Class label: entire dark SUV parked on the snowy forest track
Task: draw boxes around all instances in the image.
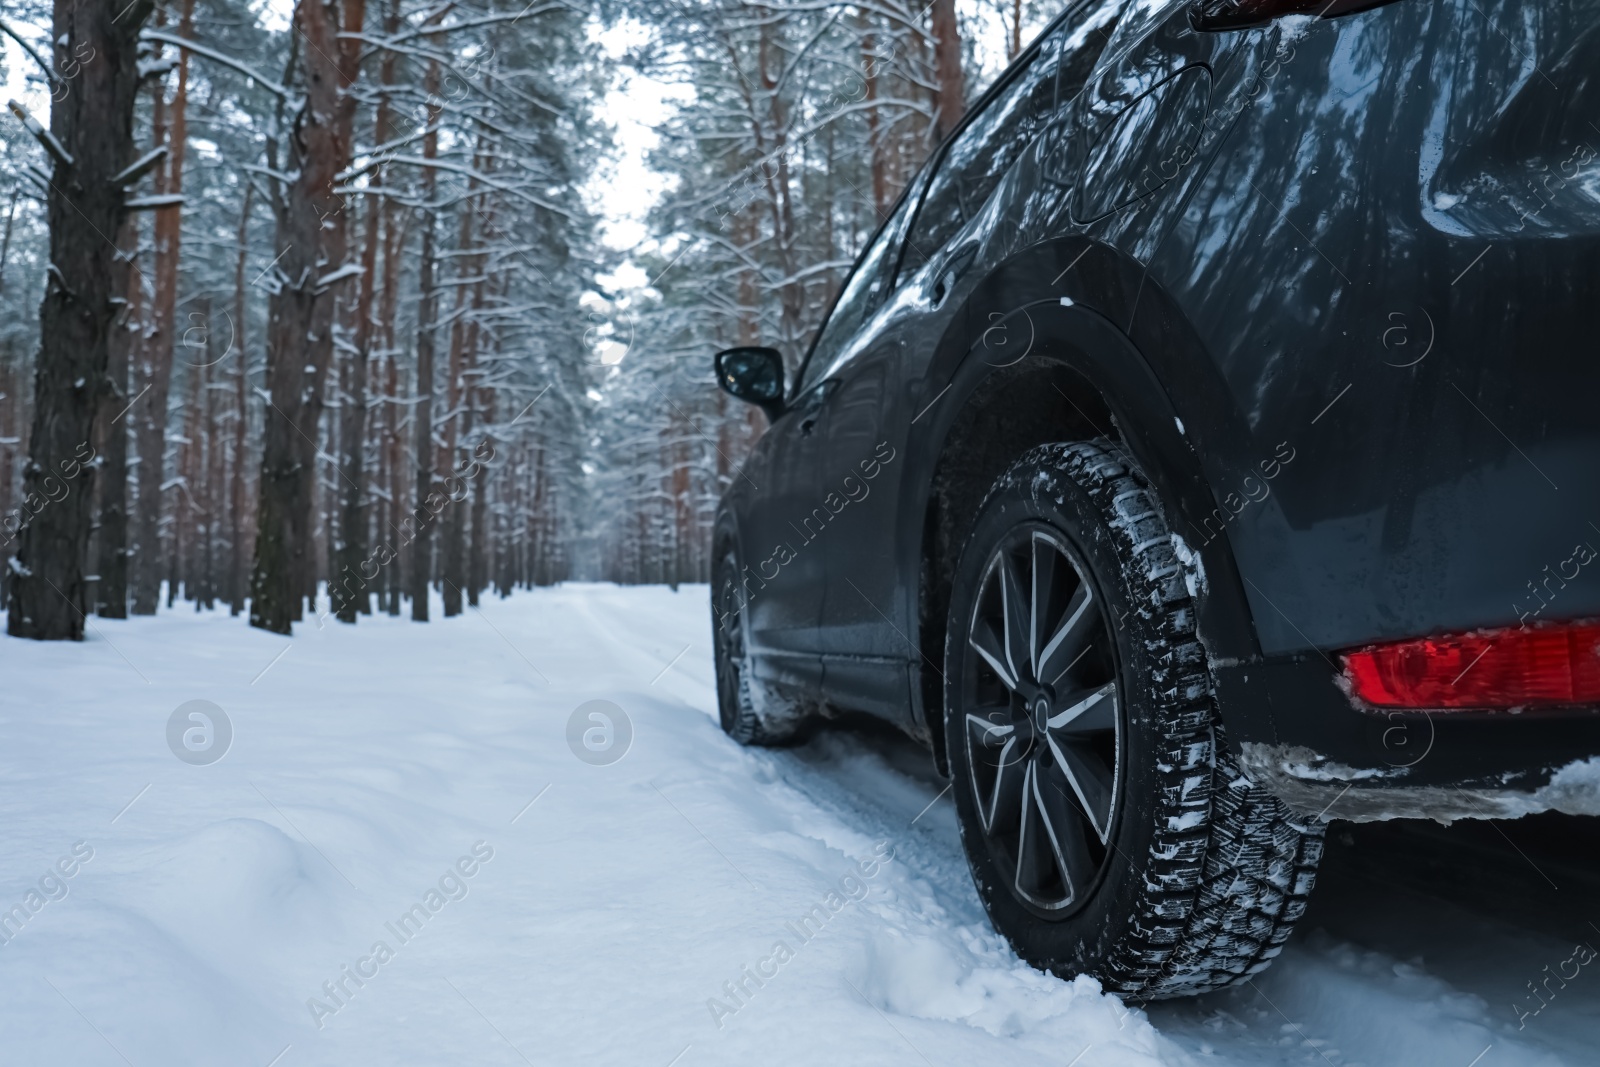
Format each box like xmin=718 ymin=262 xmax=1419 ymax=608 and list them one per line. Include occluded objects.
xmin=712 ymin=0 xmax=1600 ymax=1000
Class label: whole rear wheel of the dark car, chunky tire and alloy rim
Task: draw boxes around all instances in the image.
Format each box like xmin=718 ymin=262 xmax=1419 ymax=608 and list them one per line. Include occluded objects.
xmin=944 ymin=442 xmax=1323 ymax=1000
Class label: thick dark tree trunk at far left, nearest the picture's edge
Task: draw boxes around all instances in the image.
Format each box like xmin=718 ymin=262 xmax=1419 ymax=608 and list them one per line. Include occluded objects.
xmin=6 ymin=0 xmax=152 ymax=641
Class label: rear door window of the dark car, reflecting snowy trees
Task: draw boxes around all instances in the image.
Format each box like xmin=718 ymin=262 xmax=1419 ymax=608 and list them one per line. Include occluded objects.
xmin=901 ymin=0 xmax=1126 ymax=275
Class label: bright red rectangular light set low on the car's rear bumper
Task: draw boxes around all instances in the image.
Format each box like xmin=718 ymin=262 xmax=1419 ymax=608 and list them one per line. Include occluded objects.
xmin=1344 ymin=622 xmax=1600 ymax=709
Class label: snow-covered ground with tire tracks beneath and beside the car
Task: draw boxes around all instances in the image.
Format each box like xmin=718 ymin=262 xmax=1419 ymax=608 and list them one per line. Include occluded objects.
xmin=0 ymin=585 xmax=1600 ymax=1067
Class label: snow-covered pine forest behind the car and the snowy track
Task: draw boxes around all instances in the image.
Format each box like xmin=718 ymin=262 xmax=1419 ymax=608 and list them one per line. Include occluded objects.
xmin=0 ymin=0 xmax=1059 ymax=638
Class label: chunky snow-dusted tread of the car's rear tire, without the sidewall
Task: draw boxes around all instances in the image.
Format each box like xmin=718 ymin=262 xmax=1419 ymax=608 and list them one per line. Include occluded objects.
xmin=994 ymin=440 xmax=1323 ymax=1000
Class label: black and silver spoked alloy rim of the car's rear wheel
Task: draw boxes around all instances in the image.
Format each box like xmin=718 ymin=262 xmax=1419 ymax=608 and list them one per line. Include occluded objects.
xmin=962 ymin=525 xmax=1123 ymax=918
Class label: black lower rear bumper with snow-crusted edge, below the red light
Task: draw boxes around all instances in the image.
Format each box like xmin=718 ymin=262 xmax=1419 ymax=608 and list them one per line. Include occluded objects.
xmin=1213 ymin=653 xmax=1600 ymax=822
